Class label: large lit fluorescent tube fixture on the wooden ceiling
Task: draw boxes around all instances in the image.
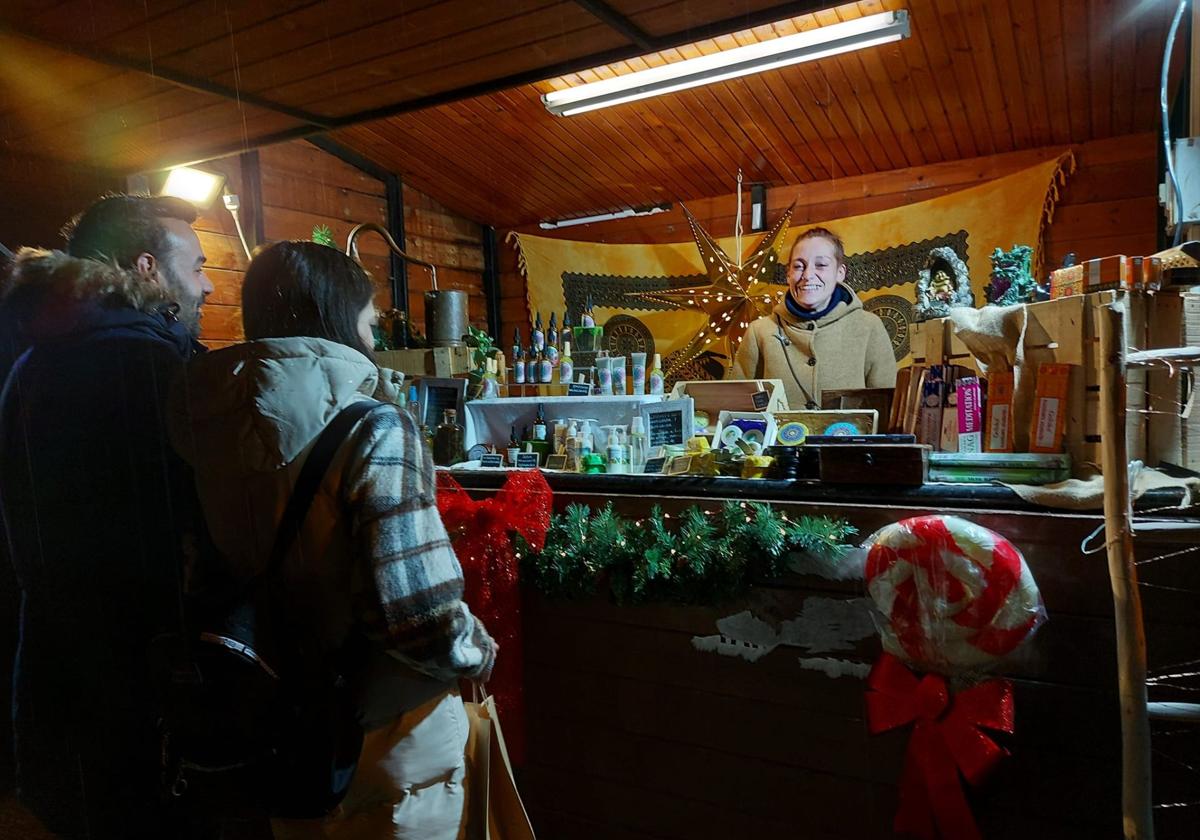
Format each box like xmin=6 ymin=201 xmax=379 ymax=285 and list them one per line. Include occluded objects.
xmin=541 ymin=10 xmax=910 ymax=116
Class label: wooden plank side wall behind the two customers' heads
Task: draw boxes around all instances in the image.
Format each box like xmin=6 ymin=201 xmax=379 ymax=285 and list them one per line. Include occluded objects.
xmin=197 ymin=140 xmax=487 ymax=347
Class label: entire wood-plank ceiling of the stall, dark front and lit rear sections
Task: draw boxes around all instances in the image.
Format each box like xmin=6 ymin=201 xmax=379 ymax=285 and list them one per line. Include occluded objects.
xmin=0 ymin=0 xmax=1178 ymax=227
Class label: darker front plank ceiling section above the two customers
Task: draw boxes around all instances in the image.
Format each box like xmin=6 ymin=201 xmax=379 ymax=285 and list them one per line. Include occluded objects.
xmin=0 ymin=0 xmax=823 ymax=172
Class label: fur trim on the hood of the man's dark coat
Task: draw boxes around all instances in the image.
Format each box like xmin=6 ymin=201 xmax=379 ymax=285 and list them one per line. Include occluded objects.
xmin=5 ymin=248 xmax=172 ymax=312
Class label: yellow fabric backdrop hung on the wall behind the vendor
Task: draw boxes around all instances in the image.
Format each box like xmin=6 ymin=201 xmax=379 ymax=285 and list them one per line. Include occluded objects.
xmin=515 ymin=154 xmax=1072 ymax=358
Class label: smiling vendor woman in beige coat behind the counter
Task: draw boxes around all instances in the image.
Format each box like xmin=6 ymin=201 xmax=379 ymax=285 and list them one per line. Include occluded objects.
xmin=730 ymin=228 xmax=896 ymax=410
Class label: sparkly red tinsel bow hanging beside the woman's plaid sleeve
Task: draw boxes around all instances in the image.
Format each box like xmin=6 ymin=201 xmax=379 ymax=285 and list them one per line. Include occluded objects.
xmin=438 ymin=469 xmax=553 ymax=764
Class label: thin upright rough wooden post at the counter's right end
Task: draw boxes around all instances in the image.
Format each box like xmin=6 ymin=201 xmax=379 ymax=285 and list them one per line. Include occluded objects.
xmin=1098 ymin=298 xmax=1154 ymax=840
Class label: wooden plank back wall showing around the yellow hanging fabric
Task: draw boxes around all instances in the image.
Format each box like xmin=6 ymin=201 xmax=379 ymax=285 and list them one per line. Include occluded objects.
xmin=500 ymin=134 xmax=1158 ymax=343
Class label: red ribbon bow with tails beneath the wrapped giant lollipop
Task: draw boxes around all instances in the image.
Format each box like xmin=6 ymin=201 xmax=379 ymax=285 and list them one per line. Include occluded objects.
xmin=866 ymin=653 xmax=1013 ymax=840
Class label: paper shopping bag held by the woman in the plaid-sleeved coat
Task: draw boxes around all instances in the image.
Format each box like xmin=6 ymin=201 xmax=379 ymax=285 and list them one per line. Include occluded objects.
xmin=460 ymin=697 xmax=535 ymax=840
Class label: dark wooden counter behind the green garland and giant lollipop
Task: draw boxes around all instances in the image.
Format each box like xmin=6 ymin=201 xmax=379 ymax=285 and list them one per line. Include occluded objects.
xmin=456 ymin=474 xmax=1200 ymax=840
